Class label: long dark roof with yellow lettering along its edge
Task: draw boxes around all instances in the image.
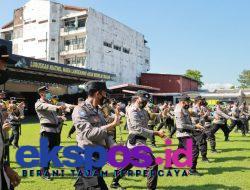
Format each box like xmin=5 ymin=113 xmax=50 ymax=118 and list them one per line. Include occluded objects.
xmin=0 ymin=39 xmax=115 ymax=85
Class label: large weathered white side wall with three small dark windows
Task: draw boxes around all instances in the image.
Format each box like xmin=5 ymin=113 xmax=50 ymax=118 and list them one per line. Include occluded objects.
xmin=86 ymin=8 xmax=150 ymax=85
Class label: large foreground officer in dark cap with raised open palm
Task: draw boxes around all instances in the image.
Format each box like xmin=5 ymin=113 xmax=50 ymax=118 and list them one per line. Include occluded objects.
xmin=72 ymin=81 xmax=120 ymax=190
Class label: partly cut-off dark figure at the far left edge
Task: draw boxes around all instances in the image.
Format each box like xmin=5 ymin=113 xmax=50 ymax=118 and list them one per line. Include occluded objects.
xmin=0 ymin=98 xmax=21 ymax=190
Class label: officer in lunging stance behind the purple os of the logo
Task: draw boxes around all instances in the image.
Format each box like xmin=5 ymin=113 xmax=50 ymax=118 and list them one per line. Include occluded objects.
xmin=111 ymin=90 xmax=165 ymax=190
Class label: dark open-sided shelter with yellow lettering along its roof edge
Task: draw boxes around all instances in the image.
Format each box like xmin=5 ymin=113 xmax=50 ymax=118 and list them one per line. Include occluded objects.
xmin=0 ymin=39 xmax=113 ymax=114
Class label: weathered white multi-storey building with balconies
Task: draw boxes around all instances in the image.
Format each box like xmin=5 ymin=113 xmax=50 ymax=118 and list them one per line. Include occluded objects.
xmin=1 ymin=0 xmax=150 ymax=85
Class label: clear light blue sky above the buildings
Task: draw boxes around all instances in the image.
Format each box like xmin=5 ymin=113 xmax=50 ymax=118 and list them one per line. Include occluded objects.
xmin=0 ymin=0 xmax=250 ymax=87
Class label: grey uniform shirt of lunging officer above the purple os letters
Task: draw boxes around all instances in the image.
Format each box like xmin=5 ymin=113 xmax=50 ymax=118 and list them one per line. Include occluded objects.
xmin=127 ymin=104 xmax=154 ymax=148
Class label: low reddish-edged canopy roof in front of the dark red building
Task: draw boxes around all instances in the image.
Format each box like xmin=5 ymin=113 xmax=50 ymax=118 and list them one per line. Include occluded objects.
xmin=109 ymin=83 xmax=160 ymax=92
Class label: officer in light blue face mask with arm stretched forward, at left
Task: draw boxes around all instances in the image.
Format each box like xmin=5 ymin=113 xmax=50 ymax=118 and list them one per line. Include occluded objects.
xmin=35 ymin=86 xmax=66 ymax=180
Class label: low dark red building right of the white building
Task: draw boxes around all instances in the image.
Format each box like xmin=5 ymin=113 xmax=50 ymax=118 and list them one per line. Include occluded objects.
xmin=140 ymin=73 xmax=199 ymax=93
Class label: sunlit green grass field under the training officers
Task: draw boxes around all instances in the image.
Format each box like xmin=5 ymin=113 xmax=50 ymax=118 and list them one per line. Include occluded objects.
xmin=7 ymin=118 xmax=250 ymax=190
